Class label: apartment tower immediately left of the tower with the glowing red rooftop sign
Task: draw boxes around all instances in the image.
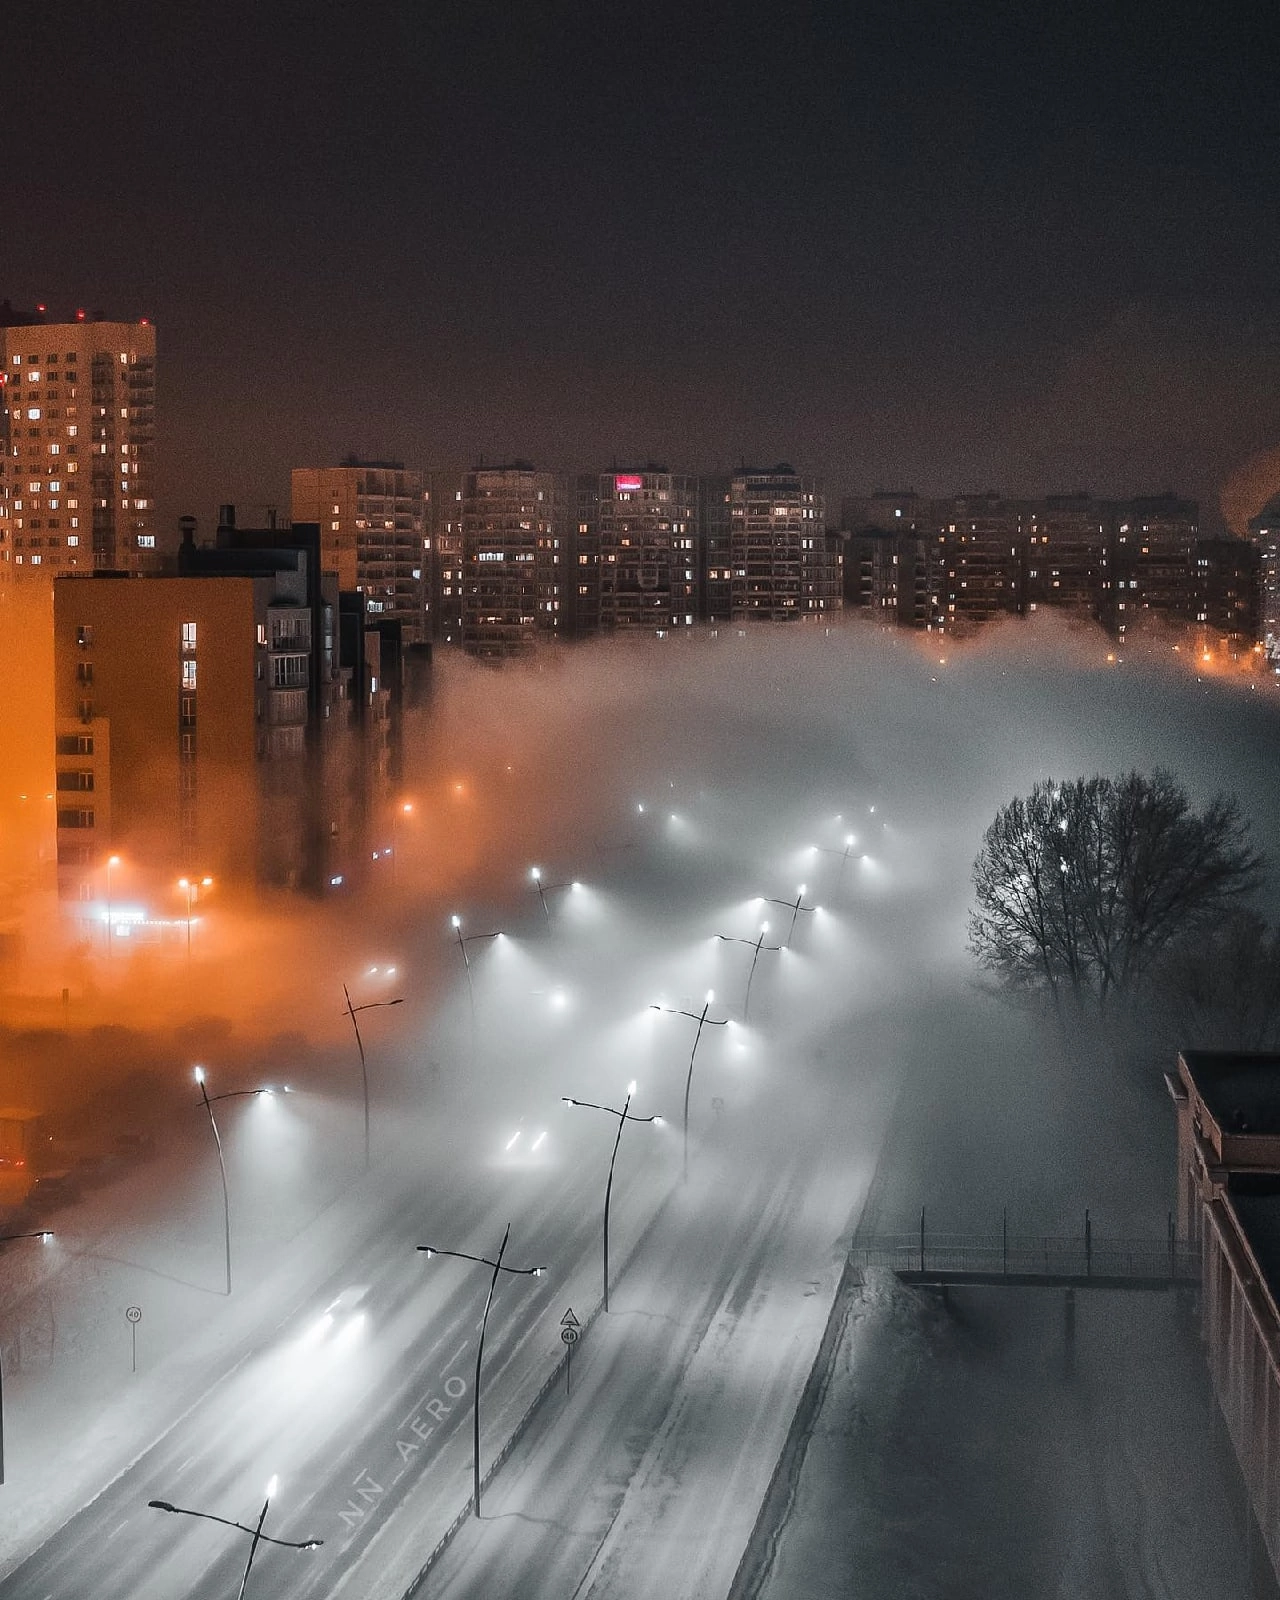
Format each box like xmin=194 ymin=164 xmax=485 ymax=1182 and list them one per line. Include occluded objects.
xmin=462 ymin=461 xmax=574 ymax=658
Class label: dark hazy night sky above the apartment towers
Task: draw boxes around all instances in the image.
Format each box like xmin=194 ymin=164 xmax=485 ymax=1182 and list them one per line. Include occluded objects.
xmin=0 ymin=0 xmax=1280 ymax=531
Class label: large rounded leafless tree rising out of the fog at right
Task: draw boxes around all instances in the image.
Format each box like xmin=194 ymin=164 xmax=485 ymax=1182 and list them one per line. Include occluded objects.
xmin=970 ymin=771 xmax=1262 ymax=1011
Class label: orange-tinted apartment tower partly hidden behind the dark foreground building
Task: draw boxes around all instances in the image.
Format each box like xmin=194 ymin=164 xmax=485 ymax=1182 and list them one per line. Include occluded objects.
xmin=291 ymin=456 xmax=429 ymax=643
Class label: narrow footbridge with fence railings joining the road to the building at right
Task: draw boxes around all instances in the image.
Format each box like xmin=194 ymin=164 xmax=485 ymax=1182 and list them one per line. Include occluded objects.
xmin=850 ymin=1214 xmax=1200 ymax=1290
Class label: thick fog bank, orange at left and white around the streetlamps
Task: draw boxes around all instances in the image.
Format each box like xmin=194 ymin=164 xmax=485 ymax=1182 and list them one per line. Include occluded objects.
xmin=0 ymin=604 xmax=1280 ymax=1593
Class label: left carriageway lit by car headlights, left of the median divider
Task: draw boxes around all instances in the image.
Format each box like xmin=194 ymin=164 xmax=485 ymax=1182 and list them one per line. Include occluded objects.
xmin=0 ymin=1081 xmax=691 ymax=1600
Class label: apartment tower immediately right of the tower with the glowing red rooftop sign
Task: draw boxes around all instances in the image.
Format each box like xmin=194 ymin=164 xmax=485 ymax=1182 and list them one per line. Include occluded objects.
xmin=728 ymin=464 xmax=842 ymax=622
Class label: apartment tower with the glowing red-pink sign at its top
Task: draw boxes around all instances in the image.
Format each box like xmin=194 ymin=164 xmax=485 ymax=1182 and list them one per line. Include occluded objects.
xmin=597 ymin=464 xmax=701 ymax=634
